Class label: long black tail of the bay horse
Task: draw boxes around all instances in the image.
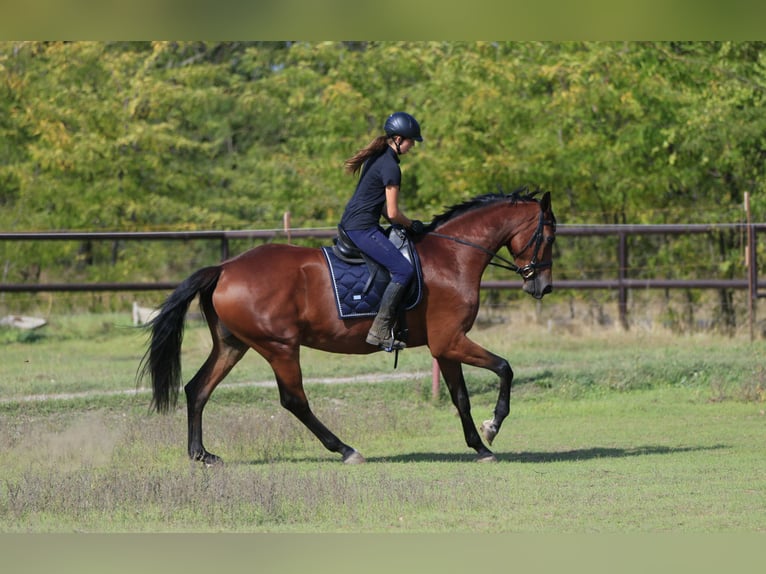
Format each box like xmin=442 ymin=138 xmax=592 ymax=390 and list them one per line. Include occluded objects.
xmin=139 ymin=266 xmax=221 ymax=413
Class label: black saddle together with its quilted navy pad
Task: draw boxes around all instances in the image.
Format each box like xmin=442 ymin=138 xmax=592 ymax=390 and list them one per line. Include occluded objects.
xmin=322 ymin=226 xmax=423 ymax=322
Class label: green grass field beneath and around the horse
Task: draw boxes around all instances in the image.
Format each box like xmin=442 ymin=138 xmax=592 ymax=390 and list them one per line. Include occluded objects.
xmin=0 ymin=316 xmax=766 ymax=533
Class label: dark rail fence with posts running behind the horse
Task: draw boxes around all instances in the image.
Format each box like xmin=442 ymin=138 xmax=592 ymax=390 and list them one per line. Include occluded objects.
xmin=0 ymin=223 xmax=766 ymax=332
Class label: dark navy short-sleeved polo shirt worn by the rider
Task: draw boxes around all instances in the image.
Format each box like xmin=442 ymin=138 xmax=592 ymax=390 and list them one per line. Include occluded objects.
xmin=340 ymin=147 xmax=402 ymax=231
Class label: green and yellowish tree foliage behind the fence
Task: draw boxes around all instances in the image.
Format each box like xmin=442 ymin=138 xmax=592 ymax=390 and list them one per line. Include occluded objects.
xmin=0 ymin=42 xmax=766 ymax=320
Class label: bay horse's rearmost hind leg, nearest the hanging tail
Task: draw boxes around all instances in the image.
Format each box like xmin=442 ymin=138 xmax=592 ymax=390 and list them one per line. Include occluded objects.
xmin=184 ymin=328 xmax=249 ymax=466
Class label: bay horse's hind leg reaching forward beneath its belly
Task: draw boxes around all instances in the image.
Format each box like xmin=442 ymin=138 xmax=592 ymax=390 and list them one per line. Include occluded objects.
xmin=269 ymin=350 xmax=365 ymax=464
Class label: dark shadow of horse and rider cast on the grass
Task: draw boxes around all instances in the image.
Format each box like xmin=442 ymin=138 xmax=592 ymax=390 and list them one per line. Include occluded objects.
xmin=234 ymin=444 xmax=731 ymax=465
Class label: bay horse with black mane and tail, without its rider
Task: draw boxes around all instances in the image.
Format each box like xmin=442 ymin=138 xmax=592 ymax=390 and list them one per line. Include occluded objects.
xmin=139 ymin=187 xmax=556 ymax=466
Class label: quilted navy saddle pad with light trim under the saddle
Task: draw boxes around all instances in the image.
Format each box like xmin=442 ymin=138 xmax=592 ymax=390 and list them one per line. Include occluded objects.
xmin=322 ymin=233 xmax=423 ymax=319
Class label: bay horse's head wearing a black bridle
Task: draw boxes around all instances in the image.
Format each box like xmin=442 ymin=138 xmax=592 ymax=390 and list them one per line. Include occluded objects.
xmin=508 ymin=191 xmax=556 ymax=299
